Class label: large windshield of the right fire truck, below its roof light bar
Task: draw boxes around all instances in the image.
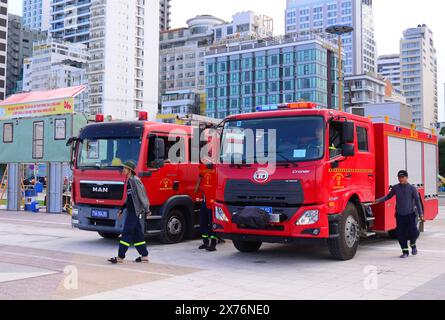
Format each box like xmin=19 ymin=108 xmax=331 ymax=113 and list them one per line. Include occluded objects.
xmin=221 ymin=116 xmax=325 ymax=164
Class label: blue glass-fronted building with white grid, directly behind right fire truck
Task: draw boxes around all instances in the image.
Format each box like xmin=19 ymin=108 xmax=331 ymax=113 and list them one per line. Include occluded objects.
xmin=206 ymin=35 xmax=338 ymax=119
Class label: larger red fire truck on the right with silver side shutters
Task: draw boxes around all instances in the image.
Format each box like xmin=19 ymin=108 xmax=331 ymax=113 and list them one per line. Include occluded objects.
xmin=214 ymin=103 xmax=438 ymax=260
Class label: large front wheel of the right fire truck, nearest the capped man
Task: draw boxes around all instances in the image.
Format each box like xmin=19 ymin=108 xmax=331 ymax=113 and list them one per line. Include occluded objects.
xmin=328 ymin=202 xmax=360 ymax=261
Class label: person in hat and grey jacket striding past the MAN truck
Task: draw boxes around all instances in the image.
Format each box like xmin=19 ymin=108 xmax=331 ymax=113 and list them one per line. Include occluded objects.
xmin=108 ymin=161 xmax=150 ymax=264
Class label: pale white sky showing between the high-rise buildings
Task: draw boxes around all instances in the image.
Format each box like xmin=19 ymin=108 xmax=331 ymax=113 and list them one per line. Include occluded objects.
xmin=9 ymin=0 xmax=445 ymax=121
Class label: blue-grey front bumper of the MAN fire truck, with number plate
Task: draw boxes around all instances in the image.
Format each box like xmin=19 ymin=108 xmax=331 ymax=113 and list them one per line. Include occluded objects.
xmin=71 ymin=205 xmax=126 ymax=234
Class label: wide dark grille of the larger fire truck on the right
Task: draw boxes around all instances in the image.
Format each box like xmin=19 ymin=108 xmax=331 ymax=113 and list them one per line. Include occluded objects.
xmin=224 ymin=180 xmax=304 ymax=205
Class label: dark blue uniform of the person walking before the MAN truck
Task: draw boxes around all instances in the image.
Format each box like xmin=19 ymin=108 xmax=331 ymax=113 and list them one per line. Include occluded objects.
xmin=119 ymin=182 xmax=148 ymax=259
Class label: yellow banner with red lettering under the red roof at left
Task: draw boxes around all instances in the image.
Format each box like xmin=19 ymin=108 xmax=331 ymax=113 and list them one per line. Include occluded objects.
xmin=0 ymin=98 xmax=74 ymax=120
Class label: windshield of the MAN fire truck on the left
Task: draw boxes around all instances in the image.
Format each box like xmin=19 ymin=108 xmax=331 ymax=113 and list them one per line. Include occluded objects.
xmin=77 ymin=138 xmax=141 ymax=169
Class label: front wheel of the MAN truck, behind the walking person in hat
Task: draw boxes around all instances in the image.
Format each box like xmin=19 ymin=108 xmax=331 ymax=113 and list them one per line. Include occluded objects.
xmin=159 ymin=209 xmax=187 ymax=244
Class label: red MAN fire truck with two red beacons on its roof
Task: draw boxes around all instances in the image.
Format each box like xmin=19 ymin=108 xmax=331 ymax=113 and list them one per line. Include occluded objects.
xmin=69 ymin=112 xmax=200 ymax=243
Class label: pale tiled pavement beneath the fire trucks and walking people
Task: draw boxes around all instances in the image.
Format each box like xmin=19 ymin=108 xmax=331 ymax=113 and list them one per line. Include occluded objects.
xmin=0 ymin=207 xmax=445 ymax=300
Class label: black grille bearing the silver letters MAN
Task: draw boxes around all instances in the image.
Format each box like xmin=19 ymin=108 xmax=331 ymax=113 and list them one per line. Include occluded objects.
xmin=80 ymin=182 xmax=124 ymax=200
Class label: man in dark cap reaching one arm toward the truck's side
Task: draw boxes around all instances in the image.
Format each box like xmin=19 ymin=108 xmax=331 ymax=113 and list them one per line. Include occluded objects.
xmin=373 ymin=170 xmax=425 ymax=259
